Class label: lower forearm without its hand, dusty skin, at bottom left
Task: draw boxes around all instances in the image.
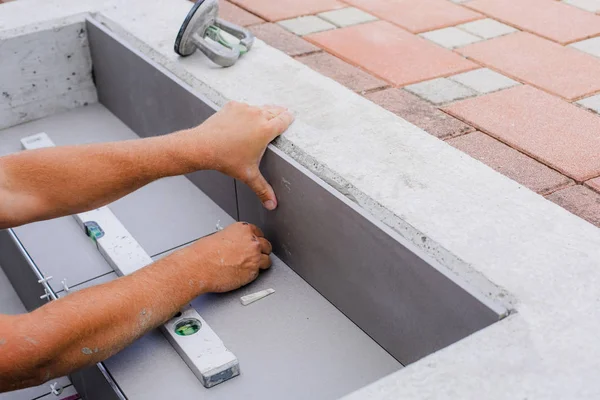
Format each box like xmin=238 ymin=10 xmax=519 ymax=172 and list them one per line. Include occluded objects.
xmin=0 ymin=245 xmax=209 ymax=392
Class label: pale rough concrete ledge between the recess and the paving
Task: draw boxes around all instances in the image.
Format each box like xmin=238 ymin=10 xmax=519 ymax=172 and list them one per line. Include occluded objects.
xmin=0 ymin=0 xmax=600 ymax=400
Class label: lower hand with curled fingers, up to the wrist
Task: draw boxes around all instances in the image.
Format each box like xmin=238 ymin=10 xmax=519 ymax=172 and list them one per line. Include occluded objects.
xmin=185 ymin=222 xmax=272 ymax=293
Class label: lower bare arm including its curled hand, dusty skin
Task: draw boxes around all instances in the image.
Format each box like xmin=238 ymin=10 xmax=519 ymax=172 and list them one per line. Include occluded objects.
xmin=0 ymin=223 xmax=271 ymax=393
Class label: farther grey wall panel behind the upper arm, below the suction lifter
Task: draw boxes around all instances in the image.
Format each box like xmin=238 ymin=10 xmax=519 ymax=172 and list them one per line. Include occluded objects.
xmin=88 ymin=21 xmax=237 ymax=218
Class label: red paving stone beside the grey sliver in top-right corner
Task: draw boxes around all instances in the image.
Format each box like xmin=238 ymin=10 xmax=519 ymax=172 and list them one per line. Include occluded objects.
xmin=465 ymin=0 xmax=600 ymax=44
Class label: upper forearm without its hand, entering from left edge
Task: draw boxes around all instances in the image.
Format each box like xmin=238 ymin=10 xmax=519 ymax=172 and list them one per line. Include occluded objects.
xmin=0 ymin=131 xmax=211 ymax=228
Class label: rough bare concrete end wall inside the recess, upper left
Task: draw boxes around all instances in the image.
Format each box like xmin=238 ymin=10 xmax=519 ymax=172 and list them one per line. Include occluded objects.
xmin=0 ymin=19 xmax=97 ymax=129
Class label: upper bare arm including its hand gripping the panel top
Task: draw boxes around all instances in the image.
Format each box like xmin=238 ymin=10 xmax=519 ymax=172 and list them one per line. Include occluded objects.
xmin=0 ymin=102 xmax=293 ymax=229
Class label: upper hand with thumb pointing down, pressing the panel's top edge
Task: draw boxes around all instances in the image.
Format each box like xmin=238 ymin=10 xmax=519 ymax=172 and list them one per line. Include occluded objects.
xmin=190 ymin=101 xmax=294 ymax=210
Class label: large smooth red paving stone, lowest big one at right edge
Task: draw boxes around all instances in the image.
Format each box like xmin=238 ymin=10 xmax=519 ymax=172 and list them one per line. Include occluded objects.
xmin=445 ymin=85 xmax=600 ymax=182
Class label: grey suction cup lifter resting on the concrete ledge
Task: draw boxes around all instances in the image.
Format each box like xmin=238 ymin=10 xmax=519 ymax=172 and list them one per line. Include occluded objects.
xmin=175 ymin=0 xmax=254 ymax=67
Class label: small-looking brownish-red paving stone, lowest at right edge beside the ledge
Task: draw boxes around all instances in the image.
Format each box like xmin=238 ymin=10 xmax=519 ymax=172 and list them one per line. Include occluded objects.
xmin=547 ymin=185 xmax=600 ymax=227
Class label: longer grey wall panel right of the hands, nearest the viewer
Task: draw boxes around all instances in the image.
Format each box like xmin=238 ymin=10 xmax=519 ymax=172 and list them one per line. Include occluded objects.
xmin=238 ymin=148 xmax=499 ymax=364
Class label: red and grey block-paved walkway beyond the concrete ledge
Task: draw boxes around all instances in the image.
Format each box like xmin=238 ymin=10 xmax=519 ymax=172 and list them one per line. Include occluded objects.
xmin=221 ymin=0 xmax=600 ymax=226
